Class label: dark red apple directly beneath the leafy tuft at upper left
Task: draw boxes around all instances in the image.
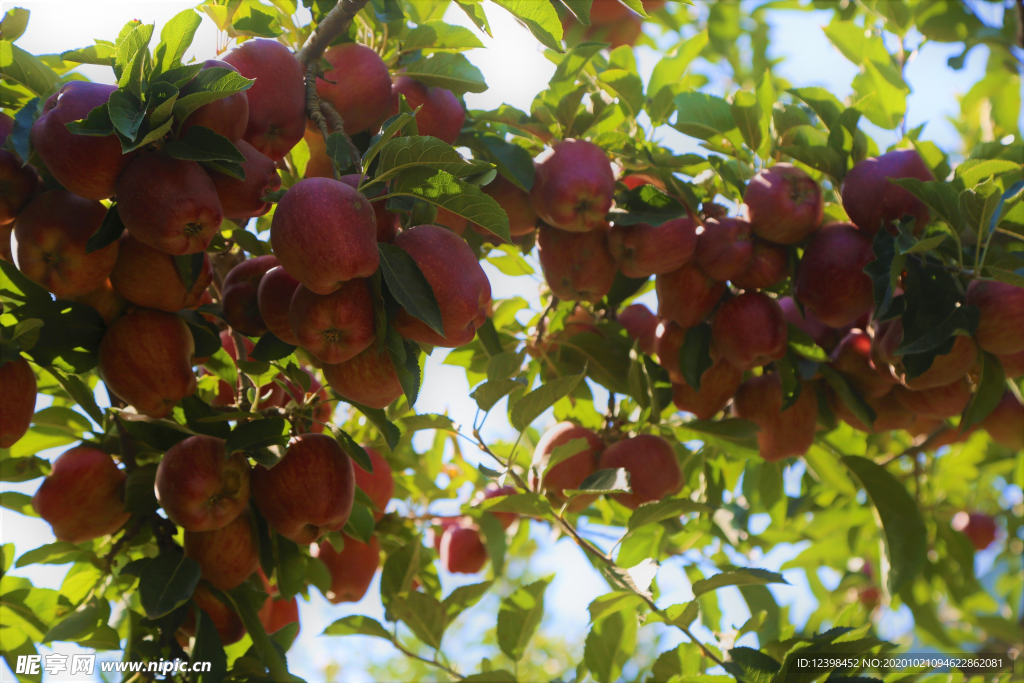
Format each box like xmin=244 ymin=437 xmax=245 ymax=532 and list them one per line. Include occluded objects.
xmin=118 ymin=152 xmax=224 ymax=256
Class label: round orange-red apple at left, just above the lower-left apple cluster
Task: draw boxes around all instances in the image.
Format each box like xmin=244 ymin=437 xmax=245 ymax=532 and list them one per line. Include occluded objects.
xmin=99 ymin=308 xmax=196 ymax=418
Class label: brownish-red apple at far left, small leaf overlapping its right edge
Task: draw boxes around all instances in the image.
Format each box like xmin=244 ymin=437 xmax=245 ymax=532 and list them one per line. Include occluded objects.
xmin=14 ymin=189 xmax=118 ymax=299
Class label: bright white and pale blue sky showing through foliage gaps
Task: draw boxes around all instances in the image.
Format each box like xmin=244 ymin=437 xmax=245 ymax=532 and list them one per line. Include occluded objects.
xmin=0 ymin=0 xmax=1011 ymax=683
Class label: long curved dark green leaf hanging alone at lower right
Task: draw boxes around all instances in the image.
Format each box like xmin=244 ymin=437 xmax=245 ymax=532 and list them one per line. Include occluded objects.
xmin=843 ymin=456 xmax=928 ymax=595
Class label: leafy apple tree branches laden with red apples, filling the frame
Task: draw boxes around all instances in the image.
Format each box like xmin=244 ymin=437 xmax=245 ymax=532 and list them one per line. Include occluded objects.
xmin=0 ymin=0 xmax=1024 ymax=683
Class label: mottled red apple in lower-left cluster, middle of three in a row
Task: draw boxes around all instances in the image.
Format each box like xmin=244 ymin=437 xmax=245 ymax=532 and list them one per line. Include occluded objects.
xmin=156 ymin=434 xmax=250 ymax=531
